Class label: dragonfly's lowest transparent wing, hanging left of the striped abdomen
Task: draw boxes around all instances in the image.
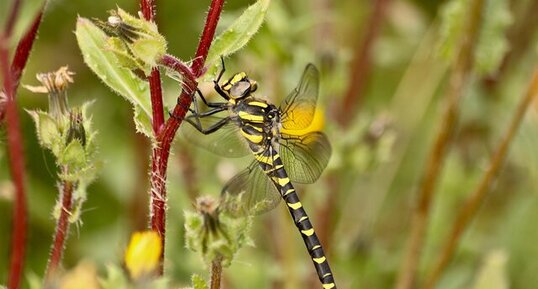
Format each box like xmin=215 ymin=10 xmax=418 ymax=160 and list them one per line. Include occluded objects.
xmin=222 ymin=161 xmax=280 ymax=215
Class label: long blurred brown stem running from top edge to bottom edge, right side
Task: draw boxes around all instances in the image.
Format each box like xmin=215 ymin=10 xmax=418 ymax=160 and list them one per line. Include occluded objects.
xmin=396 ymin=0 xmax=484 ymax=289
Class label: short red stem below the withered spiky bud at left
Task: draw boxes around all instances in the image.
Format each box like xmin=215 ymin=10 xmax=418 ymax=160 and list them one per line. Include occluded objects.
xmin=45 ymin=181 xmax=74 ymax=284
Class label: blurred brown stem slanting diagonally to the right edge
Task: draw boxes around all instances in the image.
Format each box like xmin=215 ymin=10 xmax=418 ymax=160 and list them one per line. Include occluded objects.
xmin=424 ymin=67 xmax=538 ymax=289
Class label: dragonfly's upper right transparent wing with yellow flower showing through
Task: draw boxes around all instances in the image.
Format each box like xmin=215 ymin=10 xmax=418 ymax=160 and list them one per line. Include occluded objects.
xmin=280 ymin=63 xmax=319 ymax=130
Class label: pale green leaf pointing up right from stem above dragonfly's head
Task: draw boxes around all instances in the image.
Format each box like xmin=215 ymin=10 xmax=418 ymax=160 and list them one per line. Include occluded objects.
xmin=204 ymin=0 xmax=271 ymax=80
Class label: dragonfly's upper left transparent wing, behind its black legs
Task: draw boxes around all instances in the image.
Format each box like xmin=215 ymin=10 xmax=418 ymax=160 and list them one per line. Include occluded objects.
xmin=180 ymin=116 xmax=250 ymax=158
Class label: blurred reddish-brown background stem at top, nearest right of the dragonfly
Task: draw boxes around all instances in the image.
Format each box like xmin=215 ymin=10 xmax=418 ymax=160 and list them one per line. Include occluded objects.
xmin=336 ymin=0 xmax=390 ymax=126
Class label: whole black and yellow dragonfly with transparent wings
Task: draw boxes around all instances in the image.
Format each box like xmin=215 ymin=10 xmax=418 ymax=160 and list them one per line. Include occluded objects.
xmin=183 ymin=60 xmax=336 ymax=289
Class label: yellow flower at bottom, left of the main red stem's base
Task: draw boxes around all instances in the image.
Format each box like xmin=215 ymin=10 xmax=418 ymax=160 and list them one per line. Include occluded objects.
xmin=125 ymin=231 xmax=162 ymax=280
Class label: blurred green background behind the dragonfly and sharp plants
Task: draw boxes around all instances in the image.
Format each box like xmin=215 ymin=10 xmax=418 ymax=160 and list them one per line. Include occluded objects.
xmin=0 ymin=0 xmax=538 ymax=289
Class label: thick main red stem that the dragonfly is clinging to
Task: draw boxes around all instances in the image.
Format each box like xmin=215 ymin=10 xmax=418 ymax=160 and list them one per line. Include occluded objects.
xmin=150 ymin=0 xmax=224 ymax=274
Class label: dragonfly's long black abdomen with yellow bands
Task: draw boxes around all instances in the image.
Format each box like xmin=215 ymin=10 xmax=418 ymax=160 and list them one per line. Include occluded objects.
xmin=254 ymin=144 xmax=336 ymax=289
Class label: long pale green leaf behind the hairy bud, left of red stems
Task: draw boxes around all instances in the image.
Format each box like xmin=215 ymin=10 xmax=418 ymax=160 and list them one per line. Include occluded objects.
xmin=75 ymin=17 xmax=152 ymax=137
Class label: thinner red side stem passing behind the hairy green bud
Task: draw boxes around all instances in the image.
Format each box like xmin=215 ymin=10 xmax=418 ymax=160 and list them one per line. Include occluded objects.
xmin=140 ymin=0 xmax=164 ymax=136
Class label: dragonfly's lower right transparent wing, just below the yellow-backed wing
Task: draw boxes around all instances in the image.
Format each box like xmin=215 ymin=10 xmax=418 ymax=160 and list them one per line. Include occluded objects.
xmin=279 ymin=132 xmax=331 ymax=184
